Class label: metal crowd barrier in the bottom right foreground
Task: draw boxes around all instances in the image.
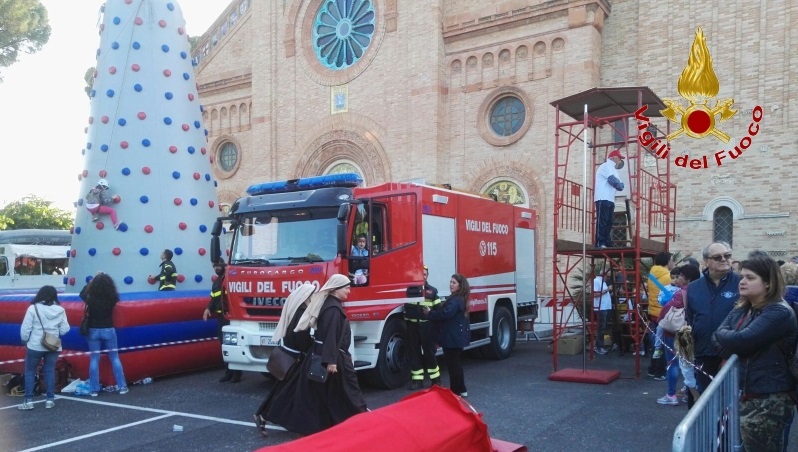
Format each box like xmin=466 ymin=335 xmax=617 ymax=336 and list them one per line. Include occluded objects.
xmin=672 ymin=355 xmax=742 ymax=452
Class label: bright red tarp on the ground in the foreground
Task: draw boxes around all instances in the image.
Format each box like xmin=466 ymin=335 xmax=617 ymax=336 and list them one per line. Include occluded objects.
xmin=260 ymin=386 xmax=526 ymax=452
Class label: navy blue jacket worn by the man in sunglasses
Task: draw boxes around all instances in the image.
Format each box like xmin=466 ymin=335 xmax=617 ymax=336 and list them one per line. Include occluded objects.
xmin=685 ymin=270 xmax=740 ymax=356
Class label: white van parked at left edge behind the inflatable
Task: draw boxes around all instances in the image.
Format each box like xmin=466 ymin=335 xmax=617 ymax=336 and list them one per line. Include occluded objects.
xmin=0 ymin=229 xmax=72 ymax=293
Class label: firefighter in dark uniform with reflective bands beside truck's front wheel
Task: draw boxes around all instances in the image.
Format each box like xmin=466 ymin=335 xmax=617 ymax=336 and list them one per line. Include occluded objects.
xmin=405 ymin=265 xmax=441 ymax=390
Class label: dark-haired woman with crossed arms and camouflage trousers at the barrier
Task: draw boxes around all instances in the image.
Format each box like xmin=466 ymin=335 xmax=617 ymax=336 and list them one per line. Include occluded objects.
xmin=712 ymin=256 xmax=798 ymax=452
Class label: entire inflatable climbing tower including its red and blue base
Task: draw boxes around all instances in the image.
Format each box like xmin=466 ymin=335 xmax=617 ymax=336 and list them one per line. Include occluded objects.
xmin=0 ymin=0 xmax=222 ymax=385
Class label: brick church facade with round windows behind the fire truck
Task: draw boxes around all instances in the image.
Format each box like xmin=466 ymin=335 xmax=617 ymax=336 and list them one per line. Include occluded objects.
xmin=193 ymin=0 xmax=798 ymax=295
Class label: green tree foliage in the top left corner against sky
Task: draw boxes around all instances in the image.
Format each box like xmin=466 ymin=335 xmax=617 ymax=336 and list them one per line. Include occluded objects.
xmin=0 ymin=0 xmax=51 ymax=80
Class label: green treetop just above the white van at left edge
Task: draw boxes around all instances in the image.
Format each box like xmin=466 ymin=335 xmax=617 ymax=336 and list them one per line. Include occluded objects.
xmin=0 ymin=194 xmax=74 ymax=229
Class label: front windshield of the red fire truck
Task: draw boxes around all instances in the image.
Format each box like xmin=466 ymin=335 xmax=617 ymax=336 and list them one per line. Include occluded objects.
xmin=231 ymin=207 xmax=338 ymax=266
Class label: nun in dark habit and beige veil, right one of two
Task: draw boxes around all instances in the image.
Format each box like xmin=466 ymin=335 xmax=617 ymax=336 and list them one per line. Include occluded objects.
xmin=264 ymin=274 xmax=367 ymax=435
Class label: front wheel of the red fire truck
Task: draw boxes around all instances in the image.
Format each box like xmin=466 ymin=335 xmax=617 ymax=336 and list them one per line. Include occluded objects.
xmin=366 ymin=317 xmax=410 ymax=389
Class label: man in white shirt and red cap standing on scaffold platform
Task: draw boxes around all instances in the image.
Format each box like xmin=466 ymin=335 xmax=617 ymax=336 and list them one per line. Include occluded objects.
xmin=593 ymin=149 xmax=623 ymax=248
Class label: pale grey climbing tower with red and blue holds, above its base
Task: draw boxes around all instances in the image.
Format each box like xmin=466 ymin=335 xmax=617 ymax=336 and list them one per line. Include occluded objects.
xmin=66 ymin=0 xmax=219 ymax=293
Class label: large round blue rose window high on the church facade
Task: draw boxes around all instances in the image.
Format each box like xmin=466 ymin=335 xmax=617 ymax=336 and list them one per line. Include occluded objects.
xmin=313 ymin=0 xmax=375 ymax=70
